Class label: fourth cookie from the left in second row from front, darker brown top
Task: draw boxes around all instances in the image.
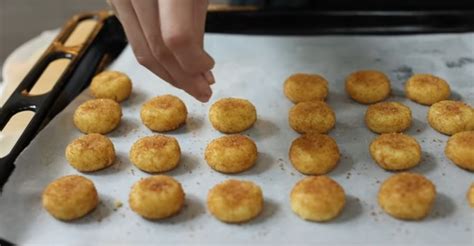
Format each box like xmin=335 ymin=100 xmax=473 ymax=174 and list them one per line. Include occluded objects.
xmin=289 ymin=133 xmax=340 ymax=175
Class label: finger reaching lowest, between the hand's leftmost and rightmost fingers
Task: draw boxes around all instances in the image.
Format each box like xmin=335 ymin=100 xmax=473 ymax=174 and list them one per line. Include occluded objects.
xmin=131 ymin=0 xmax=212 ymax=101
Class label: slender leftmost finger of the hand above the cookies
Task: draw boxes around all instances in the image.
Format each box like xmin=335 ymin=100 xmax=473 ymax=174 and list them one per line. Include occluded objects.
xmin=110 ymin=0 xmax=175 ymax=84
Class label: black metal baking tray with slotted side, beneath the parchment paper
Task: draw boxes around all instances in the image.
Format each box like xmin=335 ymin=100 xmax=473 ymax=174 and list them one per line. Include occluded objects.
xmin=0 ymin=4 xmax=474 ymax=246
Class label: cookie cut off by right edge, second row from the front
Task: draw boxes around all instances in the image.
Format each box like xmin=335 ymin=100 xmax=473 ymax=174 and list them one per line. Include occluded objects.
xmin=444 ymin=131 xmax=474 ymax=172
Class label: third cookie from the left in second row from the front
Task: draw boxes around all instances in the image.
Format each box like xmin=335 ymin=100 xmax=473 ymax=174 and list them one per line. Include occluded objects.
xmin=204 ymin=135 xmax=258 ymax=173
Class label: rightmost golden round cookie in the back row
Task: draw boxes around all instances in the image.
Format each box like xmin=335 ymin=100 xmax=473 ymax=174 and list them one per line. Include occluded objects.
xmin=405 ymin=74 xmax=451 ymax=105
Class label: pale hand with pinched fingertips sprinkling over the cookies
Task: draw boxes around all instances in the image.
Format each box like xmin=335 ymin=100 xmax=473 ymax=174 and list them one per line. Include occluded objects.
xmin=109 ymin=0 xmax=214 ymax=102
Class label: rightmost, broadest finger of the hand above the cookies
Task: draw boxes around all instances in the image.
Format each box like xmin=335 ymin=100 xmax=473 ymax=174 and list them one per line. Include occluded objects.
xmin=158 ymin=0 xmax=214 ymax=74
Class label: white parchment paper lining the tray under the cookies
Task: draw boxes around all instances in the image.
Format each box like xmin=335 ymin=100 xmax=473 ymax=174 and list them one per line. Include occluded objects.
xmin=0 ymin=34 xmax=474 ymax=245
